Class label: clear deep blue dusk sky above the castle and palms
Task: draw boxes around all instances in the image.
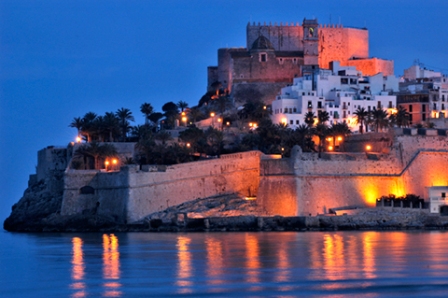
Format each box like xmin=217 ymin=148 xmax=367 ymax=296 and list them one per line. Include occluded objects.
xmin=0 ymin=0 xmax=448 ymax=221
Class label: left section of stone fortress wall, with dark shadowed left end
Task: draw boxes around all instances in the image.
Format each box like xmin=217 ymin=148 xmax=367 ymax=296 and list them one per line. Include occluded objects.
xmin=61 ymin=151 xmax=261 ymax=222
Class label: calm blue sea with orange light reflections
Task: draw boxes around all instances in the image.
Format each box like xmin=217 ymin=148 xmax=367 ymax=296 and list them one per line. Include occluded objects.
xmin=0 ymin=231 xmax=448 ymax=297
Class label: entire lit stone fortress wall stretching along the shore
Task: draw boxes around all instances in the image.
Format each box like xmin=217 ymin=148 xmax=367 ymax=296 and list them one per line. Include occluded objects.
xmin=37 ymin=130 xmax=448 ymax=223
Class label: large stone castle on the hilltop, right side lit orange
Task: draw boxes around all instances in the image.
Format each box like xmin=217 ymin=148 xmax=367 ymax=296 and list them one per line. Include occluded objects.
xmin=207 ymin=19 xmax=394 ymax=104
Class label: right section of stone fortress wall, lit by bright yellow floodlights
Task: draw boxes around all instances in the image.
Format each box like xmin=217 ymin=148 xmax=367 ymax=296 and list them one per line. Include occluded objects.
xmin=258 ymin=135 xmax=448 ymax=216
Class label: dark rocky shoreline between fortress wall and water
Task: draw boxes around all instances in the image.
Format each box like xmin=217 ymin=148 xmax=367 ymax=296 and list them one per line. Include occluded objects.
xmin=4 ymin=189 xmax=448 ymax=233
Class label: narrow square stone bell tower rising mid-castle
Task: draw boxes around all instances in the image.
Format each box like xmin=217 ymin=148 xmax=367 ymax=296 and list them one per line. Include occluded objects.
xmin=302 ymin=19 xmax=319 ymax=65
